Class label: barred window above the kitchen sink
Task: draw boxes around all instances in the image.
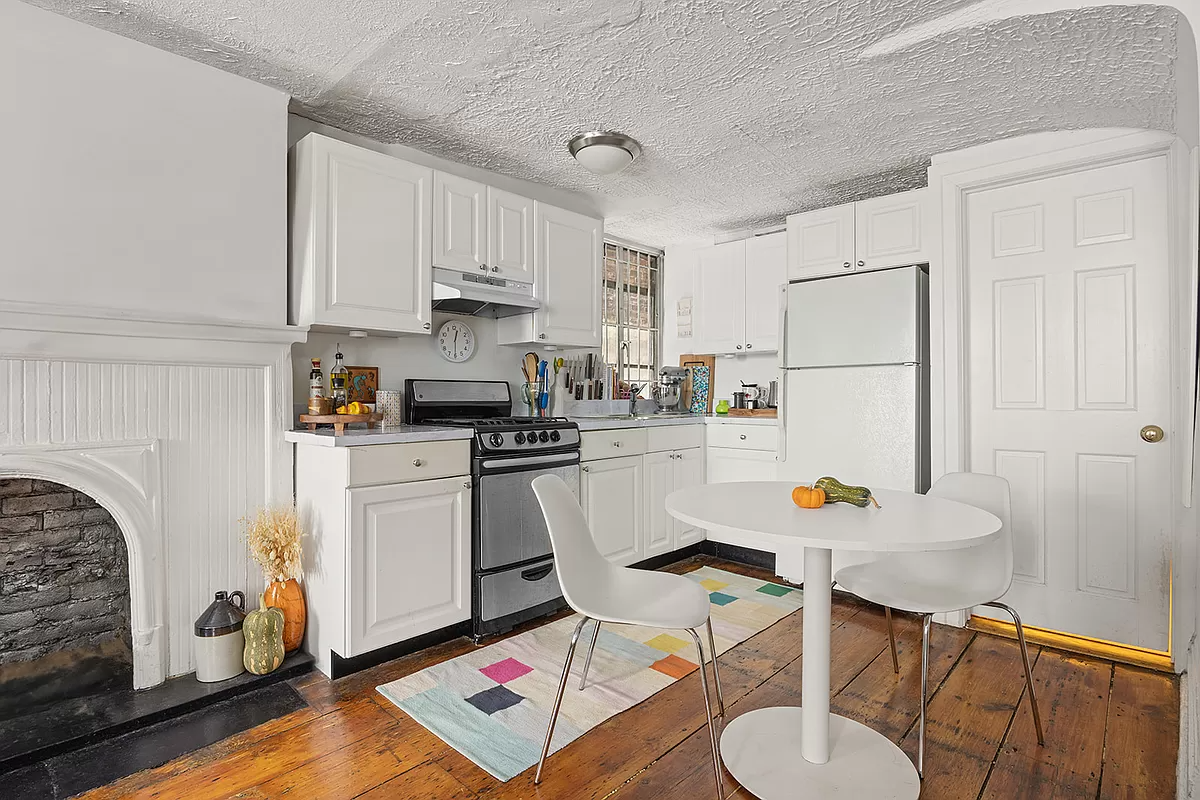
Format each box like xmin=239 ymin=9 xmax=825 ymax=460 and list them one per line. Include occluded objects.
xmin=601 ymin=242 xmax=662 ymax=386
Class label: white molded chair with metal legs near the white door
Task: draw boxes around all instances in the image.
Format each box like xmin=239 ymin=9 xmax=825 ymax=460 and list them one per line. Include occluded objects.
xmin=834 ymin=473 xmax=1045 ymax=776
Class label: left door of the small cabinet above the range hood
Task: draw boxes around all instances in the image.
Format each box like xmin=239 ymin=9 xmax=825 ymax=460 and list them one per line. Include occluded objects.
xmin=433 ymin=173 xmax=488 ymax=272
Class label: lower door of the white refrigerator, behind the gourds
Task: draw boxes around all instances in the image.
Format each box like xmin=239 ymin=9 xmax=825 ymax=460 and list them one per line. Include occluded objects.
xmin=779 ymin=366 xmax=925 ymax=492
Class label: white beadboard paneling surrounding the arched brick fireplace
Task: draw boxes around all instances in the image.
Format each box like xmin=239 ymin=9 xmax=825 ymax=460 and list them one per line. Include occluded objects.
xmin=0 ymin=359 xmax=273 ymax=675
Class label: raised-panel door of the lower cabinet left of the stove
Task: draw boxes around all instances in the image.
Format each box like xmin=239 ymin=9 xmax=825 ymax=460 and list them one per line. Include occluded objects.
xmin=343 ymin=477 xmax=470 ymax=656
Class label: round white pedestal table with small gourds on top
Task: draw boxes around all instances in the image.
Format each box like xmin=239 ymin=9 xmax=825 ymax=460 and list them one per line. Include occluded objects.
xmin=666 ymin=481 xmax=1001 ymax=800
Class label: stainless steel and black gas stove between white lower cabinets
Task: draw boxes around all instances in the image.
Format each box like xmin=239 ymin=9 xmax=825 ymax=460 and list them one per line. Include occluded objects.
xmin=404 ymin=379 xmax=580 ymax=640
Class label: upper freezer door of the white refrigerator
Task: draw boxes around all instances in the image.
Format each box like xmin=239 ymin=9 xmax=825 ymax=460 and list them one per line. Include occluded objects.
xmin=782 ymin=266 xmax=926 ymax=368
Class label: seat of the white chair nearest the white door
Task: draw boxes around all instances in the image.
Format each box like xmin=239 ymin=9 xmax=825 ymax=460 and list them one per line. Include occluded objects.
xmin=833 ymin=557 xmax=998 ymax=614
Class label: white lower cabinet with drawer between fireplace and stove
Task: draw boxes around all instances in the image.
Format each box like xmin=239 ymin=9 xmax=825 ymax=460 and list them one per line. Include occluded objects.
xmin=295 ymin=440 xmax=472 ymax=678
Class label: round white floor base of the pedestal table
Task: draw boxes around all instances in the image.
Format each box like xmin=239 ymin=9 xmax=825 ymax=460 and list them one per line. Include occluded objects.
xmin=721 ymin=705 xmax=920 ymax=800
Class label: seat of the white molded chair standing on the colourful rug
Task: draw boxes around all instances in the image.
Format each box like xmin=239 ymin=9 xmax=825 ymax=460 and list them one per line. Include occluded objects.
xmin=570 ymin=570 xmax=710 ymax=630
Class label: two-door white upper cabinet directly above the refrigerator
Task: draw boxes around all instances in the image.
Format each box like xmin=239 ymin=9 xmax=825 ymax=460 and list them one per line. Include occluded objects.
xmin=787 ymin=188 xmax=930 ymax=281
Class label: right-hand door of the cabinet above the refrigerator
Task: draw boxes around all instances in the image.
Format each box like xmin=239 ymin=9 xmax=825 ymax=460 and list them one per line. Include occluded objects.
xmin=854 ymin=190 xmax=929 ymax=270
